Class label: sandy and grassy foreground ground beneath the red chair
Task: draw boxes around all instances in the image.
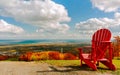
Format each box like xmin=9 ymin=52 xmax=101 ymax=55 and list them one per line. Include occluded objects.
xmin=0 ymin=60 xmax=120 ymax=75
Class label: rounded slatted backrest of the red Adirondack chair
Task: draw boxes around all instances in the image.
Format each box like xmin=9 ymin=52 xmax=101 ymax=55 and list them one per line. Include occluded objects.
xmin=92 ymin=28 xmax=111 ymax=59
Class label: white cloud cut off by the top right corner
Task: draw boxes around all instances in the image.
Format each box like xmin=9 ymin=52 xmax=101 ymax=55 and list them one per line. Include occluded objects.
xmin=91 ymin=0 xmax=120 ymax=12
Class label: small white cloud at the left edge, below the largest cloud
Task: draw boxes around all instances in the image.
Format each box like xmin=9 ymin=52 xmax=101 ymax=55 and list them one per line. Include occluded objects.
xmin=0 ymin=20 xmax=24 ymax=34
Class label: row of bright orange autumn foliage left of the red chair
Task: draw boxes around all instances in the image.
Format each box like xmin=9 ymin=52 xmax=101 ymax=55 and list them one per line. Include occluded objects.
xmin=19 ymin=51 xmax=77 ymax=61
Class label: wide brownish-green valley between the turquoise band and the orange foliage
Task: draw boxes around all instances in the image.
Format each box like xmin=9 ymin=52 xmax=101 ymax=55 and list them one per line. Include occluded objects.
xmin=0 ymin=43 xmax=88 ymax=57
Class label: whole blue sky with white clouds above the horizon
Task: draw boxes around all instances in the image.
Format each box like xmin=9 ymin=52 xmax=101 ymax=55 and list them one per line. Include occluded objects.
xmin=0 ymin=0 xmax=120 ymax=39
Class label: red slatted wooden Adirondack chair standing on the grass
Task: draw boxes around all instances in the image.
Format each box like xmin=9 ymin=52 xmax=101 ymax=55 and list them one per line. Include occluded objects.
xmin=78 ymin=28 xmax=116 ymax=70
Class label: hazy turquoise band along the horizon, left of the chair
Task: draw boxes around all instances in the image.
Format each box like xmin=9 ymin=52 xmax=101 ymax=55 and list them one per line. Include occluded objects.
xmin=0 ymin=39 xmax=90 ymax=45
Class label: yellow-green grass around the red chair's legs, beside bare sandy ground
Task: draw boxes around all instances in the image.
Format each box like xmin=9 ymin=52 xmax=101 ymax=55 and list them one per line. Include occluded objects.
xmin=39 ymin=60 xmax=120 ymax=75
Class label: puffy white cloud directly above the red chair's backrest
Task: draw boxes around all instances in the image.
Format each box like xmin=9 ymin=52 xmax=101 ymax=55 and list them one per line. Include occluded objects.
xmin=76 ymin=18 xmax=110 ymax=34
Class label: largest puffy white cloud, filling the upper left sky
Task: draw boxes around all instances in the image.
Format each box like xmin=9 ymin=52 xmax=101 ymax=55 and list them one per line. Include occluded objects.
xmin=0 ymin=0 xmax=70 ymax=33
